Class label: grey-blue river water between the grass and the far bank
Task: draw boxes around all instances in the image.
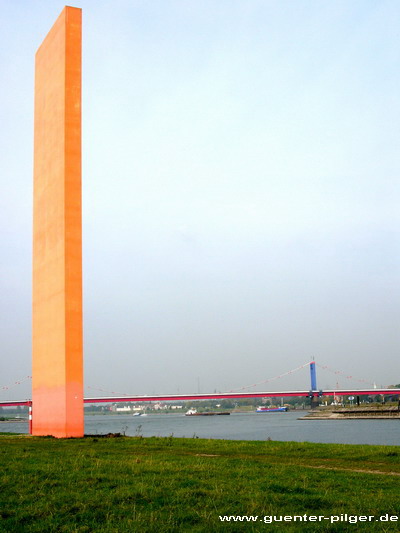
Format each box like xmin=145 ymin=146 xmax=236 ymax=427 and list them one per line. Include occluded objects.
xmin=0 ymin=411 xmax=400 ymax=445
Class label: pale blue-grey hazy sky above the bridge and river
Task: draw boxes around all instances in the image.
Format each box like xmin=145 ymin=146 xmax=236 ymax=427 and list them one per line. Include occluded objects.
xmin=0 ymin=0 xmax=400 ymax=399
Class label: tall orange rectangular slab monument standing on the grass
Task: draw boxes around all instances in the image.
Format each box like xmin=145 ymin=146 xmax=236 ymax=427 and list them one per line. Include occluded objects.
xmin=32 ymin=7 xmax=84 ymax=437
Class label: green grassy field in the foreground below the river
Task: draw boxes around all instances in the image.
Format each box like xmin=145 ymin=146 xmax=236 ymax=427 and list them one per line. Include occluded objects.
xmin=0 ymin=435 xmax=400 ymax=533
